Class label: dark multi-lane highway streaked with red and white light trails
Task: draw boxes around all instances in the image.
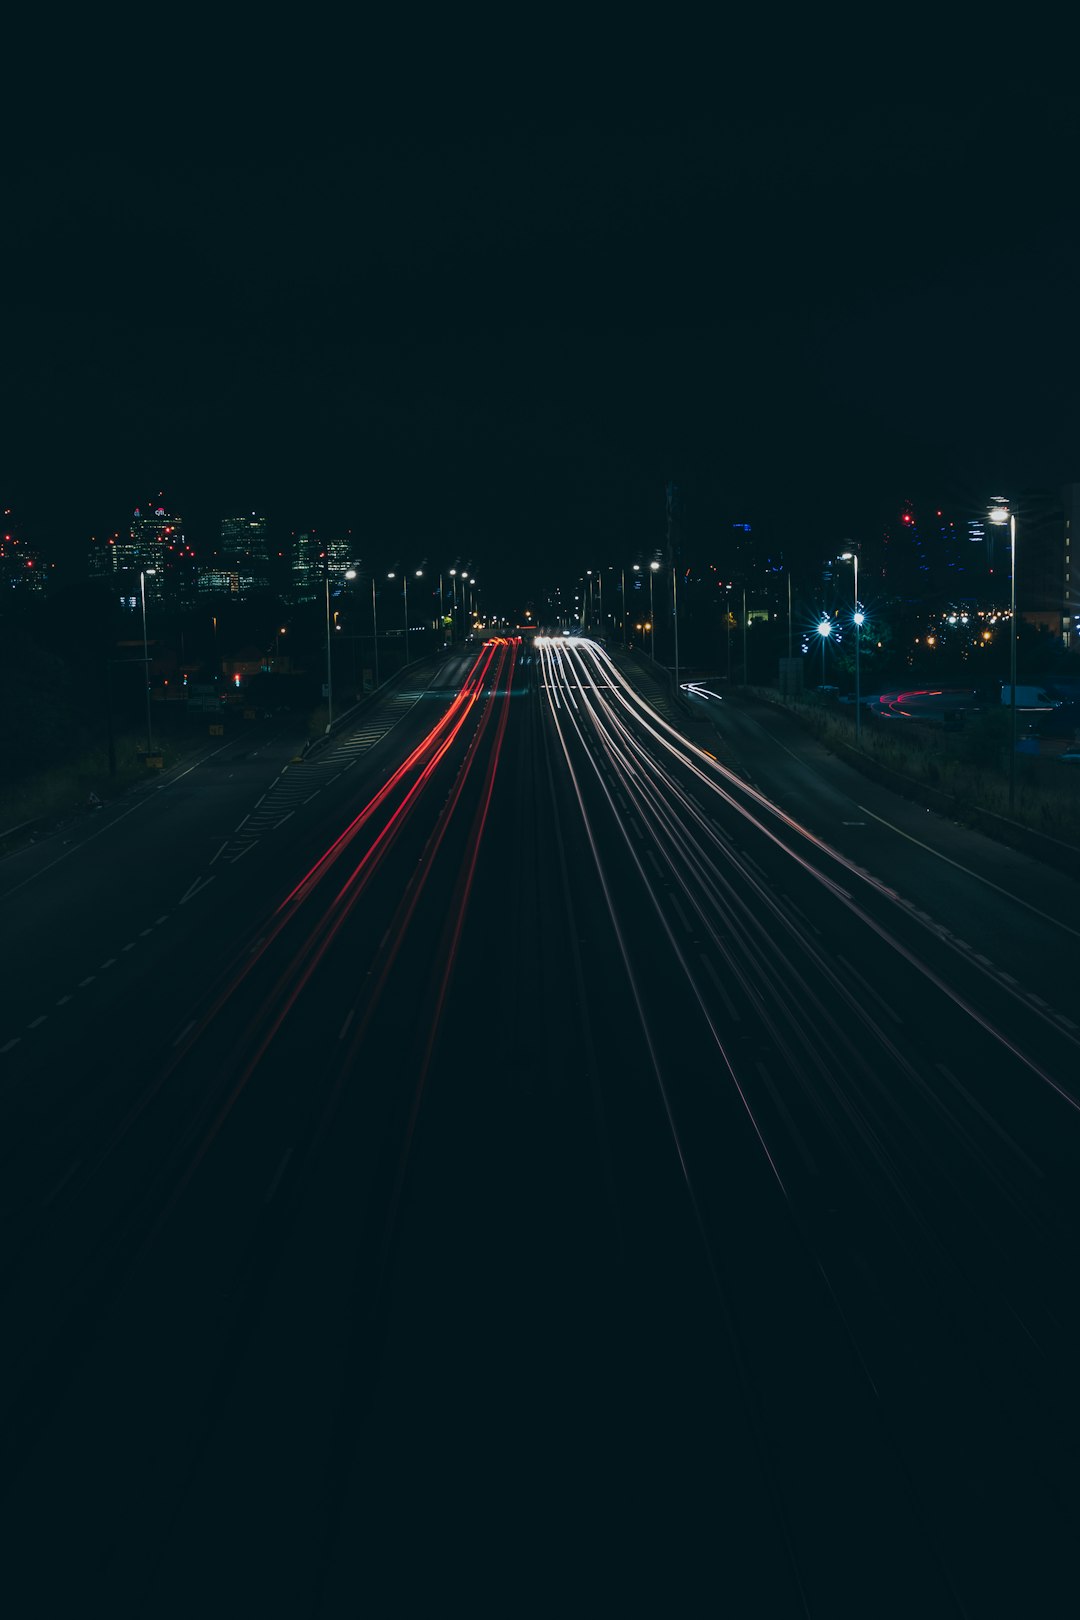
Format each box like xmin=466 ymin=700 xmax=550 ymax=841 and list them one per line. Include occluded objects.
xmin=0 ymin=638 xmax=1080 ymax=1617
